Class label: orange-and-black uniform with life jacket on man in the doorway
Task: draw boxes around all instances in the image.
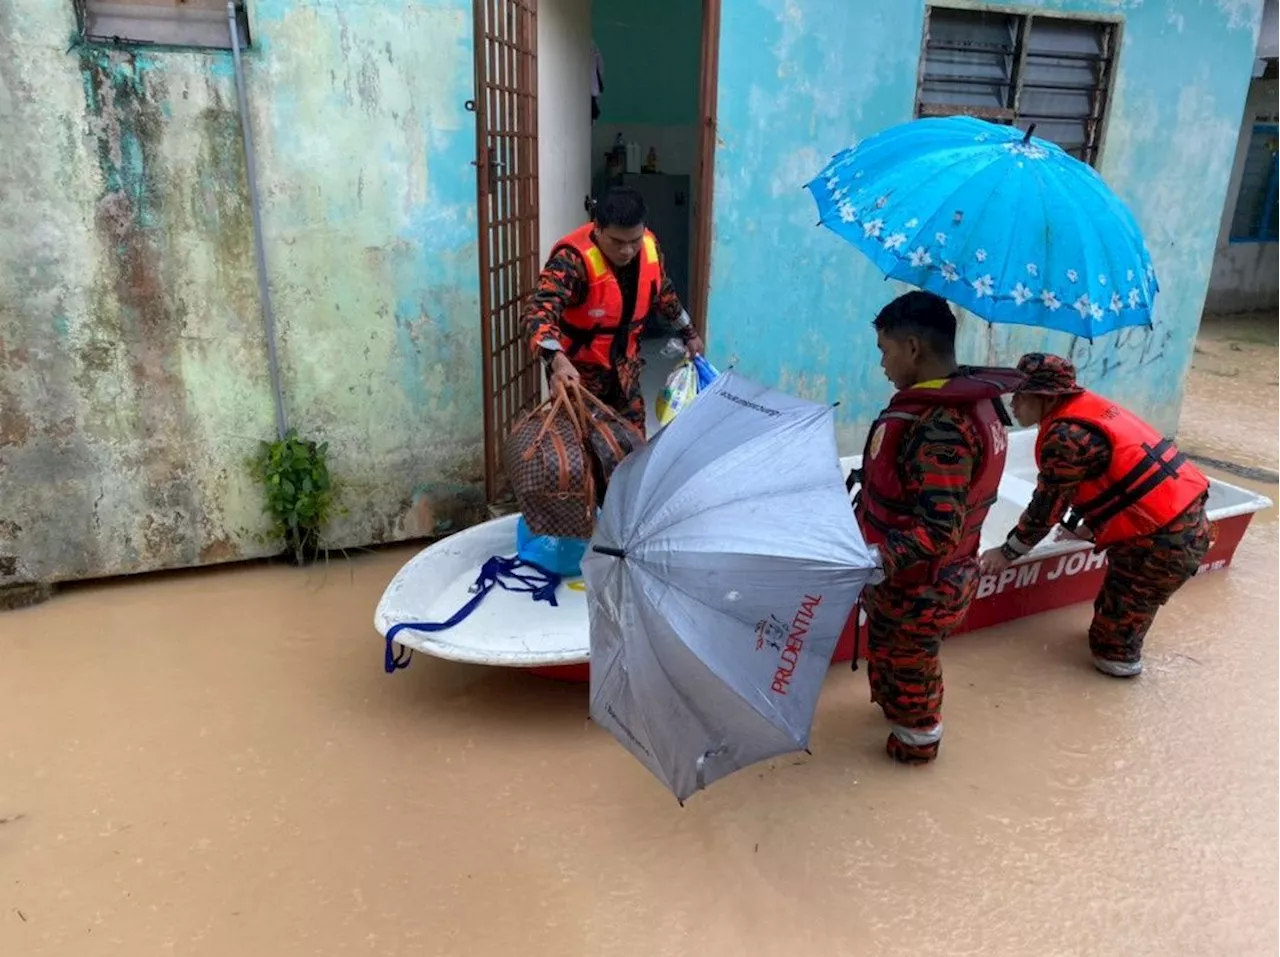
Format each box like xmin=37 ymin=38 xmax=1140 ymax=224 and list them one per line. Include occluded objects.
xmin=521 ymin=225 xmax=694 ymax=430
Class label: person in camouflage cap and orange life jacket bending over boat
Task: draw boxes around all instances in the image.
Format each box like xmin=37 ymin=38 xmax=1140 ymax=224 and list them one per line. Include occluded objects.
xmin=982 ymin=352 xmax=1213 ymax=678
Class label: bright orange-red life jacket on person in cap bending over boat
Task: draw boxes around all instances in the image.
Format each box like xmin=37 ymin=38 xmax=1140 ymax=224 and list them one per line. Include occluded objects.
xmin=1036 ymin=383 xmax=1208 ymax=546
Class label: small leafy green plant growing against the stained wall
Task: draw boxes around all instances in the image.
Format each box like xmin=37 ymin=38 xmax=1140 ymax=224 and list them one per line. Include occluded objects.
xmin=248 ymin=429 xmax=333 ymax=564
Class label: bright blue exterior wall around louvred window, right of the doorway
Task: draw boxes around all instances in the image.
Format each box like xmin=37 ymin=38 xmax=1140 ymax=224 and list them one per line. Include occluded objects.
xmin=709 ymin=0 xmax=1262 ymax=448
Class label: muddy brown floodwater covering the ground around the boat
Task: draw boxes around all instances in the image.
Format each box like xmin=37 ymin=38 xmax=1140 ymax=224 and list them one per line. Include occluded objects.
xmin=0 ymin=321 xmax=1280 ymax=957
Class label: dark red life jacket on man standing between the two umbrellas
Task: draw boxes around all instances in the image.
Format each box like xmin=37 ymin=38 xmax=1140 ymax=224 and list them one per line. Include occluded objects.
xmin=850 ymin=367 xmax=1024 ymax=582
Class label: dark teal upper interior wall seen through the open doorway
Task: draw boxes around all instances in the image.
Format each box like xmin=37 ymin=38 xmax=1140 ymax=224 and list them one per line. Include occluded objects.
xmin=591 ymin=0 xmax=703 ymax=125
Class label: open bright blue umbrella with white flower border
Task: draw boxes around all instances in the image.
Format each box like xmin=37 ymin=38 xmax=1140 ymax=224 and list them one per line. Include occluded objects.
xmin=806 ymin=116 xmax=1158 ymax=339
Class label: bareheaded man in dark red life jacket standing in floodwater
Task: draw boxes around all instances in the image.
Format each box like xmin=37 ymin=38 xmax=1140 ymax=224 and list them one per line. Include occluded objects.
xmin=850 ymin=292 xmax=1021 ymax=764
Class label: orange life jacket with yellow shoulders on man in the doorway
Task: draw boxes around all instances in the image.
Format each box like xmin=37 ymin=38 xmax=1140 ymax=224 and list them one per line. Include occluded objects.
xmin=556 ymin=224 xmax=662 ymax=368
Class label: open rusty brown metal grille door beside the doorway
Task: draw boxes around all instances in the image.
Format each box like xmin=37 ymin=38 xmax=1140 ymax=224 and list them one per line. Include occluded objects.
xmin=475 ymin=0 xmax=541 ymax=502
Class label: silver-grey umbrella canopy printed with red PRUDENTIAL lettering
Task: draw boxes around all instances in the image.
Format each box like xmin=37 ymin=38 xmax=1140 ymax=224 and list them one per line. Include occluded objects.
xmin=582 ymin=372 xmax=877 ymax=801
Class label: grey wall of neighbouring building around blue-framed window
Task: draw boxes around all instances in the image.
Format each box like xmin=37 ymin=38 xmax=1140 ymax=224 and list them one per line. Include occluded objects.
xmin=1204 ymin=79 xmax=1280 ymax=312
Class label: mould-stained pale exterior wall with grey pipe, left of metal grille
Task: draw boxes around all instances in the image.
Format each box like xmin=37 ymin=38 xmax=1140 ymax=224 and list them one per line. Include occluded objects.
xmin=0 ymin=0 xmax=481 ymax=586
